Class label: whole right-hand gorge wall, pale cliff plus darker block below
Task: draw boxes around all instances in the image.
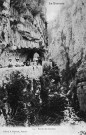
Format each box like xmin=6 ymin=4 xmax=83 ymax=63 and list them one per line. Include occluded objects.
xmin=49 ymin=0 xmax=86 ymax=111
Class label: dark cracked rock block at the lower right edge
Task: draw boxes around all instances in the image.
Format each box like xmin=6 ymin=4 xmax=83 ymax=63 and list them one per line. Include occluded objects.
xmin=77 ymin=62 xmax=86 ymax=112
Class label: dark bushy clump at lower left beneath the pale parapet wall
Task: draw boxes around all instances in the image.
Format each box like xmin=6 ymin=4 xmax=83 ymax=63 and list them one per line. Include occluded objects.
xmin=0 ymin=71 xmax=37 ymax=125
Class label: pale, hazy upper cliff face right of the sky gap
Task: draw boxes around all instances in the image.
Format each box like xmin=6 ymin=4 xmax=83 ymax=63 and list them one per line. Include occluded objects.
xmin=49 ymin=0 xmax=86 ymax=69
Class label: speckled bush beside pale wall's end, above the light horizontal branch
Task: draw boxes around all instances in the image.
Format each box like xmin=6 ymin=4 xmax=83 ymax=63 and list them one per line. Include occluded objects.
xmin=40 ymin=65 xmax=60 ymax=96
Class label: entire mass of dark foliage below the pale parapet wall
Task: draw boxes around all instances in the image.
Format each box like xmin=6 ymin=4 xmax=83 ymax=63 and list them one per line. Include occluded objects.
xmin=0 ymin=66 xmax=66 ymax=126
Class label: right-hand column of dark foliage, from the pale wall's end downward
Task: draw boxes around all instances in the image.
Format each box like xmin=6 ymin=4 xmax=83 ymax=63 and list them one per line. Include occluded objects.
xmin=40 ymin=65 xmax=67 ymax=123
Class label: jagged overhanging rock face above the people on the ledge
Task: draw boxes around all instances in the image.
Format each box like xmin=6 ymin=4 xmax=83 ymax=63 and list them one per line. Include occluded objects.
xmin=0 ymin=0 xmax=47 ymax=67
